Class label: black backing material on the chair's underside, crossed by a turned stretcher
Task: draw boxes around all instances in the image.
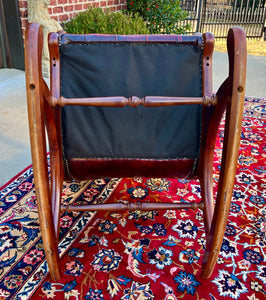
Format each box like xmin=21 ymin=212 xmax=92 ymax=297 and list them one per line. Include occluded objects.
xmin=60 ymin=42 xmax=202 ymax=159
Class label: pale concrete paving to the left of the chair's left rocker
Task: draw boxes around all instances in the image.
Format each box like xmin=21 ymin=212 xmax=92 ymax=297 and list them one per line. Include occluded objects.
xmin=0 ymin=69 xmax=31 ymax=187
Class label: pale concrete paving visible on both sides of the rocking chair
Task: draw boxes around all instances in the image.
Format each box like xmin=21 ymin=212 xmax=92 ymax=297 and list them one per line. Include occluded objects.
xmin=0 ymin=52 xmax=266 ymax=187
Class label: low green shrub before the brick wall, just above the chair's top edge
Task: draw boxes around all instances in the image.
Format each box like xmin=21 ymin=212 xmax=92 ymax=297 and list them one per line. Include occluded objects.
xmin=62 ymin=7 xmax=149 ymax=35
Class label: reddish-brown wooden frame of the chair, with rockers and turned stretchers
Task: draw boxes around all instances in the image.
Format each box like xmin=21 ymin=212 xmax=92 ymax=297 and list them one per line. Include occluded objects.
xmin=25 ymin=23 xmax=246 ymax=280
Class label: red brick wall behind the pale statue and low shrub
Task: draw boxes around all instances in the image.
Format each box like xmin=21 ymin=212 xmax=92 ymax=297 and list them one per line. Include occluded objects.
xmin=18 ymin=0 xmax=127 ymax=37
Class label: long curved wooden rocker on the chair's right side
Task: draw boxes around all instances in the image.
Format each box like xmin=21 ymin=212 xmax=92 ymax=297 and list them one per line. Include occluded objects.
xmin=202 ymin=27 xmax=247 ymax=279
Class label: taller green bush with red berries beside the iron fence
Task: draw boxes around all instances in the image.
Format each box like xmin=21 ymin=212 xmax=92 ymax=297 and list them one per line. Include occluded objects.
xmin=127 ymin=0 xmax=190 ymax=34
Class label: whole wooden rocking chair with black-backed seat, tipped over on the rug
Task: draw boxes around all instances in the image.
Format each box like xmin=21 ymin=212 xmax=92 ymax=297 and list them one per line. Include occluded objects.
xmin=25 ymin=23 xmax=246 ymax=280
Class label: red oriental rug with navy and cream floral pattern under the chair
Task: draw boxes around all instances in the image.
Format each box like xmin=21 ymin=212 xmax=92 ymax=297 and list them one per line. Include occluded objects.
xmin=0 ymin=98 xmax=266 ymax=300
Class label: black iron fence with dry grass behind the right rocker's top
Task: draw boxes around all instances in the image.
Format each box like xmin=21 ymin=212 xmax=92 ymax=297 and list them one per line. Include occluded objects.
xmin=180 ymin=0 xmax=266 ymax=38
